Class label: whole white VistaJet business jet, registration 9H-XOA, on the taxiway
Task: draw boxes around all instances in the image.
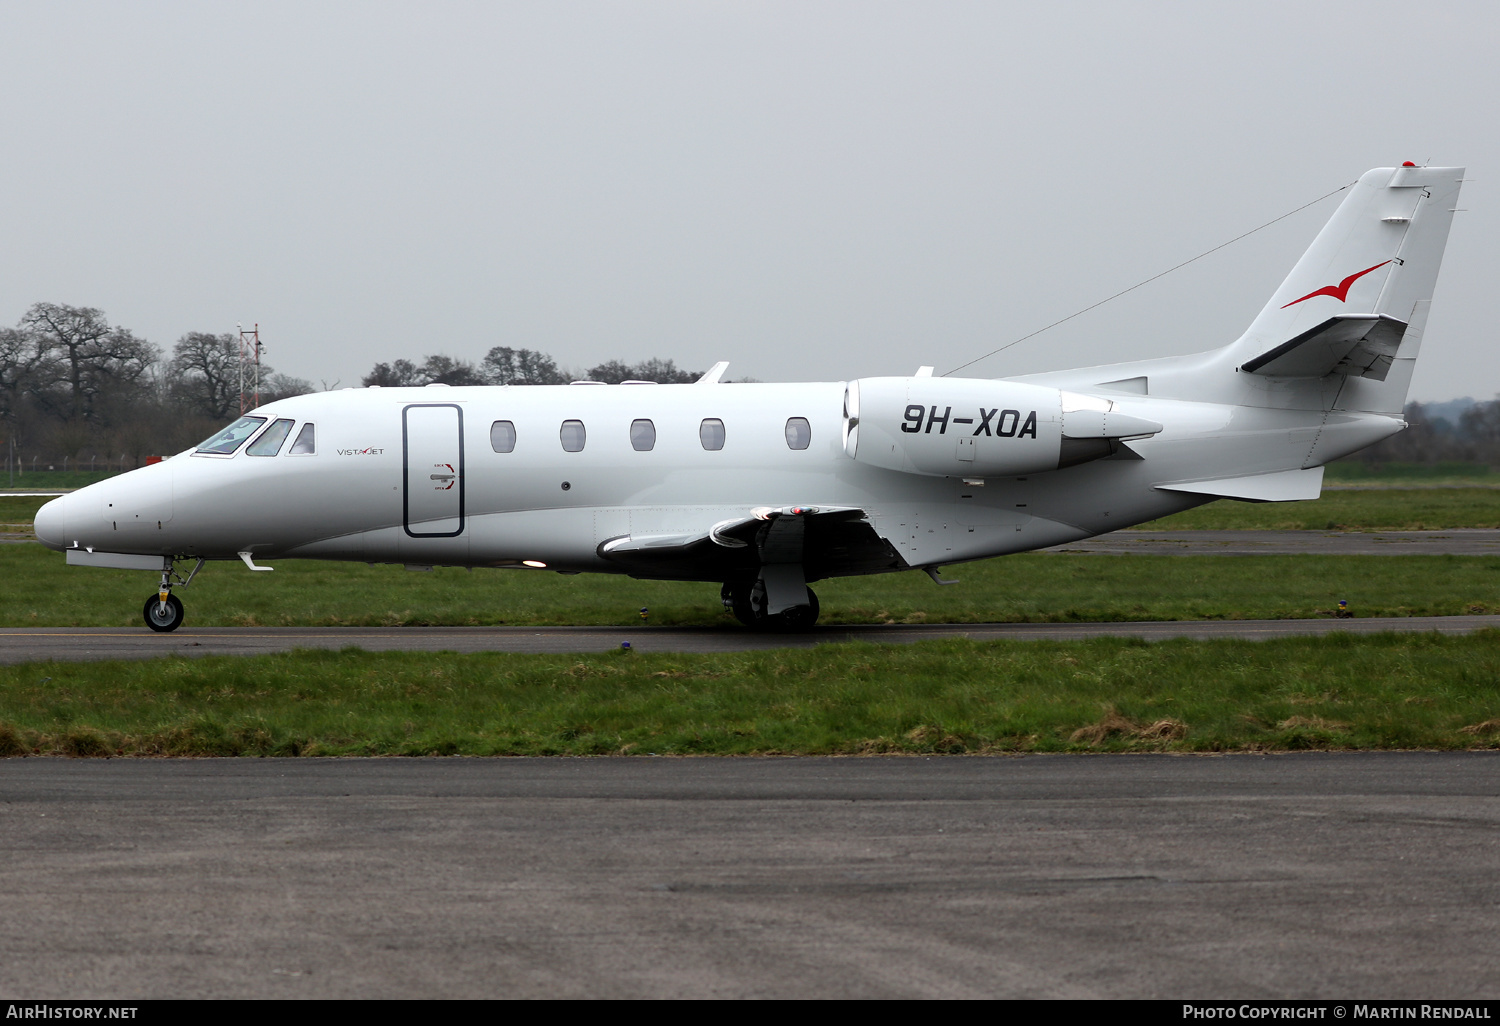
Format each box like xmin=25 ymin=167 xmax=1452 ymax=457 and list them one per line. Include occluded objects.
xmin=36 ymin=165 xmax=1463 ymax=630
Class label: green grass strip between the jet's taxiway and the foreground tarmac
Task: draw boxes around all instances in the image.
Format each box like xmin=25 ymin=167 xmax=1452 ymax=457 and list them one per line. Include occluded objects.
xmin=0 ymin=632 xmax=1500 ymax=756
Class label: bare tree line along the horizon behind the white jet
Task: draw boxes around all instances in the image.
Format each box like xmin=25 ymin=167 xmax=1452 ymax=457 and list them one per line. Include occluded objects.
xmin=0 ymin=303 xmax=1500 ymax=468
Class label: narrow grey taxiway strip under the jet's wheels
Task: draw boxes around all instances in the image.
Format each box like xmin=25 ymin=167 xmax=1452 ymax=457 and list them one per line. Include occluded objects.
xmin=0 ymin=615 xmax=1500 ymax=663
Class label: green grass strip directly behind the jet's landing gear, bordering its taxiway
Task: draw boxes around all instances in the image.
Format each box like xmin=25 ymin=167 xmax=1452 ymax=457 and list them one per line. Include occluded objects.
xmin=0 ymin=543 xmax=1500 ymax=629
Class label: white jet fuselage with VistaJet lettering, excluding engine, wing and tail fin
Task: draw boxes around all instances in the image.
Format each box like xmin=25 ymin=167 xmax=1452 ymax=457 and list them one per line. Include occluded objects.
xmin=36 ymin=378 xmax=1400 ymax=579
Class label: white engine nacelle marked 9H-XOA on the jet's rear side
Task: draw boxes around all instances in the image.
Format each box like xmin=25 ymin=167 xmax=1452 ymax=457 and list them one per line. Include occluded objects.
xmin=845 ymin=378 xmax=1161 ymax=479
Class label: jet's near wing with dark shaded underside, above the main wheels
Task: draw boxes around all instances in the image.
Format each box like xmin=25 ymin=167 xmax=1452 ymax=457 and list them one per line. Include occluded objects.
xmin=599 ymin=506 xmax=906 ymax=582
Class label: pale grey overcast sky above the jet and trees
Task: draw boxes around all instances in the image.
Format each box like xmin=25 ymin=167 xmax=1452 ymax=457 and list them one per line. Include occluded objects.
xmin=0 ymin=0 xmax=1500 ymax=401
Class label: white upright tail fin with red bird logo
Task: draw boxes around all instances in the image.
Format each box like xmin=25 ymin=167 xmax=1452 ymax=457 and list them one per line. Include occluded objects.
xmin=1230 ymin=167 xmax=1464 ymax=413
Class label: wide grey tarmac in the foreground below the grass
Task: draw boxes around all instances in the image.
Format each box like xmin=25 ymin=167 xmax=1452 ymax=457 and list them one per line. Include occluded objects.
xmin=0 ymin=753 xmax=1500 ymax=1001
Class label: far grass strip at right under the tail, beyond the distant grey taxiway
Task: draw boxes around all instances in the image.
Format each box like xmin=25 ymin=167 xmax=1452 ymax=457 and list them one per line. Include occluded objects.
xmin=1136 ymin=488 xmax=1500 ymax=531
